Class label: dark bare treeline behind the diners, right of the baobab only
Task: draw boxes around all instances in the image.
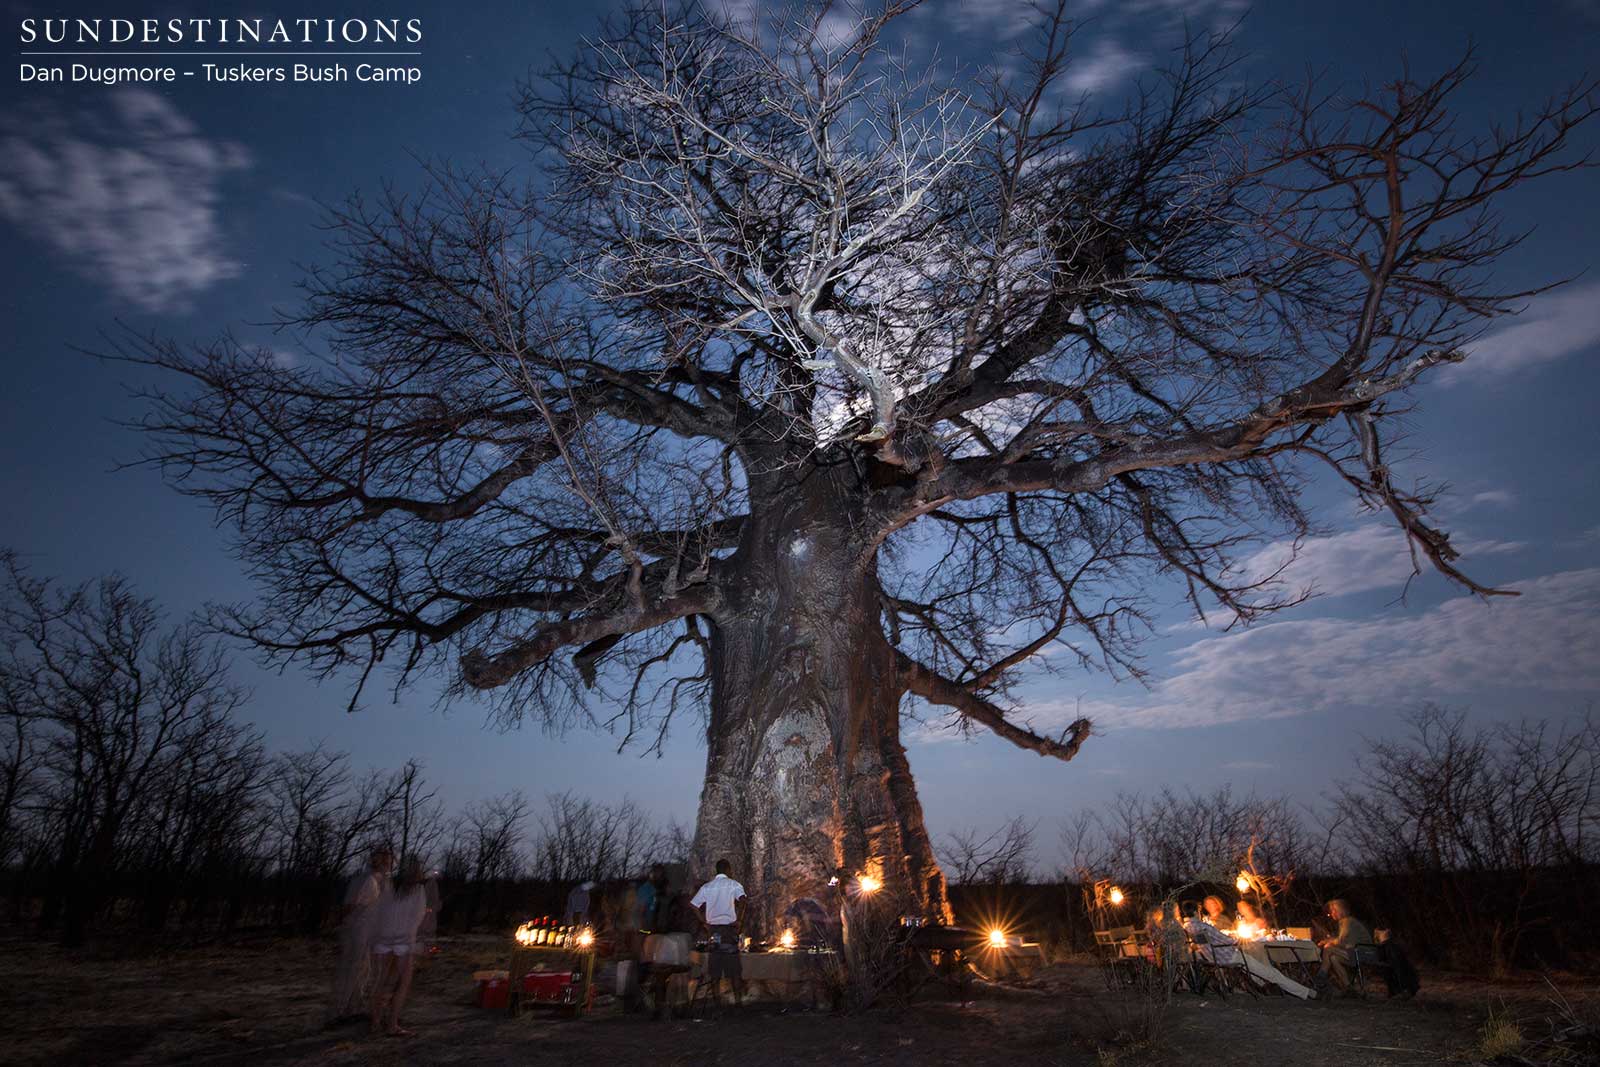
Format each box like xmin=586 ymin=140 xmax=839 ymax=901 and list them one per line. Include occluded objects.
xmin=941 ymin=705 xmax=1600 ymax=973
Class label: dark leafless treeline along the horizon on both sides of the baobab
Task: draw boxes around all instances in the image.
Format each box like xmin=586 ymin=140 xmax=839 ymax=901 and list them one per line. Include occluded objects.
xmin=0 ymin=557 xmax=1600 ymax=971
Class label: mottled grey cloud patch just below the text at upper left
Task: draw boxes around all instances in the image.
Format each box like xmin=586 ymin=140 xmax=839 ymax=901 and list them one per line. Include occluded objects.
xmin=0 ymin=88 xmax=248 ymax=312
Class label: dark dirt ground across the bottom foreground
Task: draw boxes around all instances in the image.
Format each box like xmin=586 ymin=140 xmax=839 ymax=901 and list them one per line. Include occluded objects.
xmin=0 ymin=936 xmax=1600 ymax=1067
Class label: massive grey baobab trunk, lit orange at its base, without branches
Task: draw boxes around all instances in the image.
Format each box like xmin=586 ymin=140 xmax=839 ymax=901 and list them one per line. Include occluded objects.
xmin=693 ymin=467 xmax=949 ymax=933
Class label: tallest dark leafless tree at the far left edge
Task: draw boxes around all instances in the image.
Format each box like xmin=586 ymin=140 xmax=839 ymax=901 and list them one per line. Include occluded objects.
xmin=0 ymin=553 xmax=259 ymax=942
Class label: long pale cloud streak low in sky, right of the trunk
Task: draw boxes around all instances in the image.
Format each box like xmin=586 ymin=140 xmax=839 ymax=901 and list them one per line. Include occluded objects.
xmin=1049 ymin=568 xmax=1600 ymax=729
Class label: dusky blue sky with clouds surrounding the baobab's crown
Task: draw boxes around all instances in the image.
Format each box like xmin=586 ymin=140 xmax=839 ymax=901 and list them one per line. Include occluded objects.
xmin=0 ymin=0 xmax=1600 ymax=857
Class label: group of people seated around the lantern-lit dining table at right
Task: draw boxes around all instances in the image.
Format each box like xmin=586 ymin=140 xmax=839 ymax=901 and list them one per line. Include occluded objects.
xmin=1146 ymin=896 xmax=1419 ymax=1000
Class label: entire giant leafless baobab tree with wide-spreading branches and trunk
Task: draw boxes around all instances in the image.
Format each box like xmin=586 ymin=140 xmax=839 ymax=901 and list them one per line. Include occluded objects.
xmin=122 ymin=3 xmax=1594 ymax=921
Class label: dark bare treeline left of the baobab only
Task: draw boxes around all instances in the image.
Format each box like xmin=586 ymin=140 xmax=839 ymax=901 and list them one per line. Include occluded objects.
xmin=0 ymin=557 xmax=686 ymax=944
